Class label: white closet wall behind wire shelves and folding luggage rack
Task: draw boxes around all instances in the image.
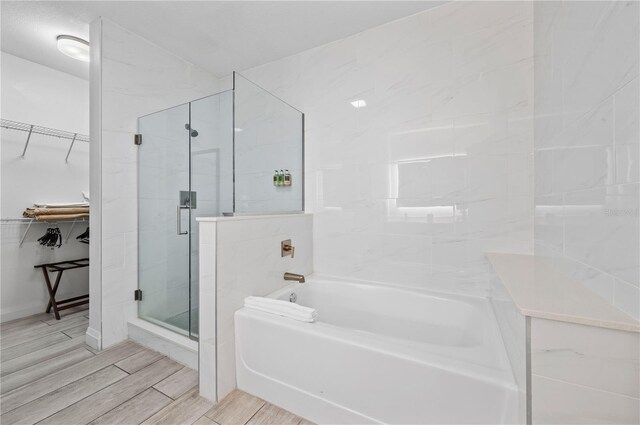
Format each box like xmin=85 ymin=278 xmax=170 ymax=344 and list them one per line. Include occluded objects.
xmin=0 ymin=52 xmax=89 ymax=321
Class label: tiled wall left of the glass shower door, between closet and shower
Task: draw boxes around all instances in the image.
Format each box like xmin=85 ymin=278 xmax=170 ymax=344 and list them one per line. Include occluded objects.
xmin=89 ymin=19 xmax=218 ymax=347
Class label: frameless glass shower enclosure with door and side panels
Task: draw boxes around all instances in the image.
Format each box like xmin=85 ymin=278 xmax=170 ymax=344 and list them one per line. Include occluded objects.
xmin=138 ymin=73 xmax=304 ymax=338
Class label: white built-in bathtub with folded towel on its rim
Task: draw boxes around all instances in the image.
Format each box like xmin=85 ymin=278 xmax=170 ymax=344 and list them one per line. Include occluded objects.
xmin=235 ymin=279 xmax=517 ymax=424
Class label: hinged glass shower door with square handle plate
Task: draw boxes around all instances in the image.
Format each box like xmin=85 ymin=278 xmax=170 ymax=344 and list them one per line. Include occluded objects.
xmin=138 ymin=104 xmax=191 ymax=336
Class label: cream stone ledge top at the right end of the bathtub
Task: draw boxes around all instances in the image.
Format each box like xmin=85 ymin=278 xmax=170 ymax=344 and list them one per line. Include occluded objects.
xmin=487 ymin=253 xmax=640 ymax=332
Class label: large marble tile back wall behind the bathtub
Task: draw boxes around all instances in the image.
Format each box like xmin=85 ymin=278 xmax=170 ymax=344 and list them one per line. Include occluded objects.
xmin=234 ymin=1 xmax=533 ymax=293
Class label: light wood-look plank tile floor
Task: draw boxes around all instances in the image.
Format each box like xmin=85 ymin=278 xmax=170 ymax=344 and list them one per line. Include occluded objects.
xmin=0 ymin=310 xmax=309 ymax=425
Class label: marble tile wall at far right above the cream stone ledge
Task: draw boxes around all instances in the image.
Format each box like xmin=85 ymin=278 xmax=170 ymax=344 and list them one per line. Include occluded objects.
xmin=534 ymin=1 xmax=640 ymax=318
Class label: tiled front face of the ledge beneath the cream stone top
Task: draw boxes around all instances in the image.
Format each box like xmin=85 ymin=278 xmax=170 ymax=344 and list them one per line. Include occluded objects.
xmin=531 ymin=318 xmax=640 ymax=424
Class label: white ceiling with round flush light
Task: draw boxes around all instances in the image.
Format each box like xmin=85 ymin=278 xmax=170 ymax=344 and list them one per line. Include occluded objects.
xmin=0 ymin=1 xmax=443 ymax=79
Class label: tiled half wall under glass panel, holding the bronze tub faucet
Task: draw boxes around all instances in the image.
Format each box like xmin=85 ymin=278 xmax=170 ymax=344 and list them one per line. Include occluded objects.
xmin=200 ymin=214 xmax=314 ymax=401
